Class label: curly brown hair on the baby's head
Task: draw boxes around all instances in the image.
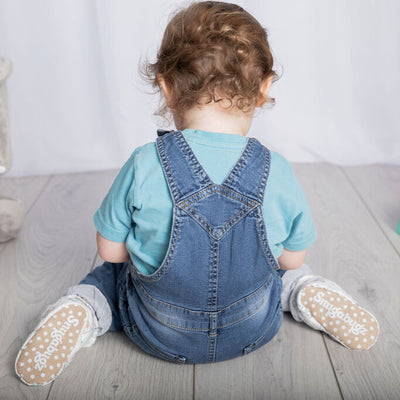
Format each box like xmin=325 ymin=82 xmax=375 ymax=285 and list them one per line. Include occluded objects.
xmin=139 ymin=1 xmax=279 ymax=123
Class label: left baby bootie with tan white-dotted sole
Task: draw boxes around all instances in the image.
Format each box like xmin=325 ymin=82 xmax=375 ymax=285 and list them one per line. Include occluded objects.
xmin=15 ymin=296 xmax=98 ymax=386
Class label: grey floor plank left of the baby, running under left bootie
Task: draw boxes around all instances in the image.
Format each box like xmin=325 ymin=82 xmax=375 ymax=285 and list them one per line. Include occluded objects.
xmin=0 ymin=173 xmax=114 ymax=399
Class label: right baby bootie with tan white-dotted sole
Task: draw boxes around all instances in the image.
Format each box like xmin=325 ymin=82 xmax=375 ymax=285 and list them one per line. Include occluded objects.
xmin=290 ymin=275 xmax=379 ymax=350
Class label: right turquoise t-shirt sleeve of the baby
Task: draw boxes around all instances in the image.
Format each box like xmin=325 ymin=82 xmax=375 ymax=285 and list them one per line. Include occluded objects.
xmin=282 ymin=166 xmax=317 ymax=251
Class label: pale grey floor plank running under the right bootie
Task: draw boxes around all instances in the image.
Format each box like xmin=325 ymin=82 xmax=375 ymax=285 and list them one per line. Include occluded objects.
xmin=295 ymin=164 xmax=400 ymax=400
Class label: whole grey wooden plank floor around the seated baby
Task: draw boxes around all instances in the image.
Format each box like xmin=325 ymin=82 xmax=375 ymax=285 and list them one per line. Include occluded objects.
xmin=0 ymin=164 xmax=400 ymax=400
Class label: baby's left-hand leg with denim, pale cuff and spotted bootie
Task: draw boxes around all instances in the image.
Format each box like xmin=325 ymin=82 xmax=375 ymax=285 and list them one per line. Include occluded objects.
xmin=15 ymin=262 xmax=124 ymax=386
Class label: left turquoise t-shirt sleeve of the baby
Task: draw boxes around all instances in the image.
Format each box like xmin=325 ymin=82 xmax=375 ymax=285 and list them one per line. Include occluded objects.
xmin=93 ymin=151 xmax=137 ymax=243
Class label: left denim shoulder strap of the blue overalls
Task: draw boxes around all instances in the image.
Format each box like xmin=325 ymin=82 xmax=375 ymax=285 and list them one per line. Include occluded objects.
xmin=156 ymin=130 xmax=213 ymax=203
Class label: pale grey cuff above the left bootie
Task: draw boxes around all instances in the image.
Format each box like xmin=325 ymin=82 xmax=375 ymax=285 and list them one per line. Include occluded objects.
xmin=66 ymin=284 xmax=112 ymax=336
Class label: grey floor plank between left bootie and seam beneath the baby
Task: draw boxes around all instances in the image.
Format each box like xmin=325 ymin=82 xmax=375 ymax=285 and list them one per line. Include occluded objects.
xmin=49 ymin=257 xmax=193 ymax=400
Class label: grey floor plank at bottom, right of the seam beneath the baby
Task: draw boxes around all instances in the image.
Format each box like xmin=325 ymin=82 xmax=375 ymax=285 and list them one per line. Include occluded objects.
xmin=195 ymin=315 xmax=341 ymax=400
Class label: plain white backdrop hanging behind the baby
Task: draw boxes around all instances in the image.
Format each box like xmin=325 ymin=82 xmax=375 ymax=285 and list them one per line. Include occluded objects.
xmin=0 ymin=0 xmax=400 ymax=176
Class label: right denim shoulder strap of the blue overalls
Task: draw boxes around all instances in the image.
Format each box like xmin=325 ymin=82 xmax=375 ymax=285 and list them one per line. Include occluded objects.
xmin=222 ymin=138 xmax=271 ymax=204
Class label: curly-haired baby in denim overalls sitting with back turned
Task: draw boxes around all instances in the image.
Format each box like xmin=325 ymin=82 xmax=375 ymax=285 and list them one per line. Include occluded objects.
xmin=15 ymin=1 xmax=379 ymax=385
